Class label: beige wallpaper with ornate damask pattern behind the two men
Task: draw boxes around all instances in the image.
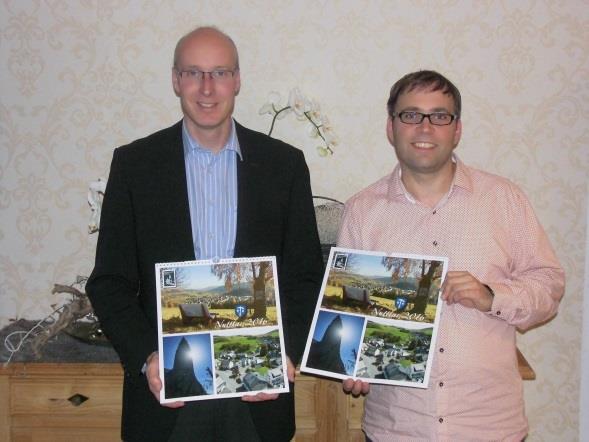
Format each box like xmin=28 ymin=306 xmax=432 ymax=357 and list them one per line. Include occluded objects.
xmin=0 ymin=0 xmax=589 ymax=441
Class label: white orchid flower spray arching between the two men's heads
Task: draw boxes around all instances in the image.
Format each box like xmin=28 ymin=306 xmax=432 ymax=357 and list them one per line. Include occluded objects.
xmin=258 ymin=87 xmax=337 ymax=157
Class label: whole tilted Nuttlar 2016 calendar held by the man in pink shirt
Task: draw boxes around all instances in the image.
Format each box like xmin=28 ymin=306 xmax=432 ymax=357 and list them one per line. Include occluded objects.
xmin=301 ymin=247 xmax=448 ymax=388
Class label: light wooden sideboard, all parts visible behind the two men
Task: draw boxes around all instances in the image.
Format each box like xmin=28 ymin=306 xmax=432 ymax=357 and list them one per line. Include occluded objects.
xmin=0 ymin=351 xmax=535 ymax=442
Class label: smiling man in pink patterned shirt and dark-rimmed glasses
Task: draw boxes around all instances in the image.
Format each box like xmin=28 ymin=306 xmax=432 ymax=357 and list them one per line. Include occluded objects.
xmin=338 ymin=71 xmax=564 ymax=442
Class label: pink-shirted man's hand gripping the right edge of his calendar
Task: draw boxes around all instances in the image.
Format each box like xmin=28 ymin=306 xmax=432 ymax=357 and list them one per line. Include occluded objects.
xmin=442 ymin=272 xmax=493 ymax=312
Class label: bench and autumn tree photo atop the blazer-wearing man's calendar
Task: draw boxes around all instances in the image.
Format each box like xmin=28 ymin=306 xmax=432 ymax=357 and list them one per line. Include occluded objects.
xmin=159 ymin=260 xmax=278 ymax=334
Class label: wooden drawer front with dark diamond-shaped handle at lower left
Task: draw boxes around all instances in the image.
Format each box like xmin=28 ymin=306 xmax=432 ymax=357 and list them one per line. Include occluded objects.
xmin=10 ymin=377 xmax=121 ymax=426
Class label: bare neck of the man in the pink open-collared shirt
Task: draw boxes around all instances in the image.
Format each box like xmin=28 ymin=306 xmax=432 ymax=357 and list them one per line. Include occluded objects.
xmin=401 ymin=162 xmax=456 ymax=207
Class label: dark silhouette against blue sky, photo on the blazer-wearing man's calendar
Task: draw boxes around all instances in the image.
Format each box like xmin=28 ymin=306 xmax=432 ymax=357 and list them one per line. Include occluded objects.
xmin=162 ymin=333 xmax=214 ymax=400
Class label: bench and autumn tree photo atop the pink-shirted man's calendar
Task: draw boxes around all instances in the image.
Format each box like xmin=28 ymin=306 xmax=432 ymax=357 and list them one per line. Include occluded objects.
xmin=321 ymin=252 xmax=444 ymax=323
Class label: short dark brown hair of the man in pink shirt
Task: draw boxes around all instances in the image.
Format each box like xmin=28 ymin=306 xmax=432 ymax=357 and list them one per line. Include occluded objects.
xmin=387 ymin=71 xmax=462 ymax=119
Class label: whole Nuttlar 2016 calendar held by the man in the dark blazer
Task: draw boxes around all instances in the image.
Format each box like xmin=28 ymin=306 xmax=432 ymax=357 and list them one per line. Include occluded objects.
xmin=155 ymin=256 xmax=289 ymax=403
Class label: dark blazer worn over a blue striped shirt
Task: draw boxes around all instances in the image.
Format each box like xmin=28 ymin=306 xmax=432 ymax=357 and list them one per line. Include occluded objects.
xmin=86 ymin=122 xmax=323 ymax=441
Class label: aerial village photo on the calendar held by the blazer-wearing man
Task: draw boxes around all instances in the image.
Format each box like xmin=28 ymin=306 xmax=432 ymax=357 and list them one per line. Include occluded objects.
xmin=213 ymin=329 xmax=285 ymax=394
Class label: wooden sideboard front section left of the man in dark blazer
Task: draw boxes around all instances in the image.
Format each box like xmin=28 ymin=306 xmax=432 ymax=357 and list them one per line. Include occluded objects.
xmin=0 ymin=363 xmax=122 ymax=442
